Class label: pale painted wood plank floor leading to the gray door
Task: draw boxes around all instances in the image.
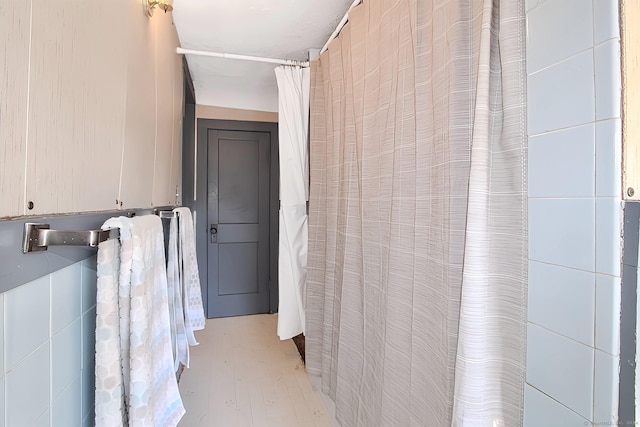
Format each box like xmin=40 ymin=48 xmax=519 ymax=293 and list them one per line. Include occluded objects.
xmin=180 ymin=314 xmax=332 ymax=427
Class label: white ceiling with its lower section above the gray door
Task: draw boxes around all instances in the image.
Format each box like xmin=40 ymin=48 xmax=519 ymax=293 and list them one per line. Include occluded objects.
xmin=173 ymin=0 xmax=352 ymax=111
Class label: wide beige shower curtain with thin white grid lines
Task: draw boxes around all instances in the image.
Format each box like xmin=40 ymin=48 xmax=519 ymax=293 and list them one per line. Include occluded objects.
xmin=306 ymin=0 xmax=527 ymax=427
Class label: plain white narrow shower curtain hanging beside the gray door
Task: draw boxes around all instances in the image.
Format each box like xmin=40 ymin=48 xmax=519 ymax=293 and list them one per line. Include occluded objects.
xmin=275 ymin=66 xmax=310 ymax=340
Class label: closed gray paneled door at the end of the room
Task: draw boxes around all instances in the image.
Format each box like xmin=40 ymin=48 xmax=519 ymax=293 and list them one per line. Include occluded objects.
xmin=207 ymin=129 xmax=271 ymax=317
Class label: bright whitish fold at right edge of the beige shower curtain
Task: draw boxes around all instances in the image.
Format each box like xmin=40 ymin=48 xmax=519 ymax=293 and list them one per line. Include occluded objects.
xmin=454 ymin=0 xmax=528 ymax=425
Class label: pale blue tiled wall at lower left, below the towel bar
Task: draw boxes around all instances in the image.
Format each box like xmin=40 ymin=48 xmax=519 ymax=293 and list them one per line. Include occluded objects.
xmin=0 ymin=257 xmax=96 ymax=427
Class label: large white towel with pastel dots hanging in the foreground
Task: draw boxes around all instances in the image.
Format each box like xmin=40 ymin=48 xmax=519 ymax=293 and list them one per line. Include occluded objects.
xmin=96 ymin=215 xmax=185 ymax=427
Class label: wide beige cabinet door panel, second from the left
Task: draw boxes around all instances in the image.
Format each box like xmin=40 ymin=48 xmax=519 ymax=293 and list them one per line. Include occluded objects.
xmin=26 ymin=0 xmax=128 ymax=214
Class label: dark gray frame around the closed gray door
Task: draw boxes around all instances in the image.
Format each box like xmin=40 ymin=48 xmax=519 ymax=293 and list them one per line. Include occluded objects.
xmin=192 ymin=119 xmax=280 ymax=317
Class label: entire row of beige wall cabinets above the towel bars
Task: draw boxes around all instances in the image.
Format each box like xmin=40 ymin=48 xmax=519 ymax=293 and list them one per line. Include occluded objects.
xmin=0 ymin=0 xmax=183 ymax=218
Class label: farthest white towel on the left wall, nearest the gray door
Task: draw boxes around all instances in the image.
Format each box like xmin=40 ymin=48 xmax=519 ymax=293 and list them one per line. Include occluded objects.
xmin=174 ymin=208 xmax=205 ymax=345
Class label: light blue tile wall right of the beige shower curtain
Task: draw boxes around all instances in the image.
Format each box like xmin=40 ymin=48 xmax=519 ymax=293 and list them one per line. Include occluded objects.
xmin=525 ymin=0 xmax=622 ymax=427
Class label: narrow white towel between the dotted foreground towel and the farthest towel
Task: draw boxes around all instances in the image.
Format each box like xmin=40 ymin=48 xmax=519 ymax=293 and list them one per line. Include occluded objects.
xmin=167 ymin=216 xmax=189 ymax=371
